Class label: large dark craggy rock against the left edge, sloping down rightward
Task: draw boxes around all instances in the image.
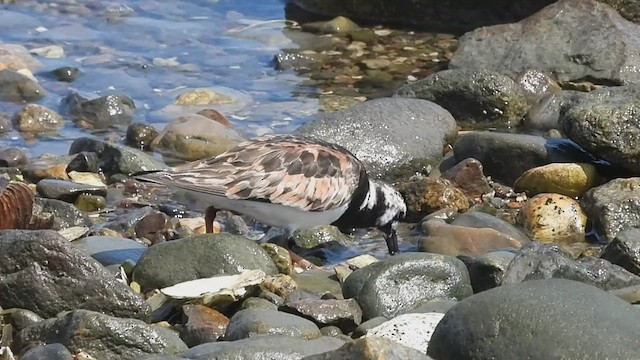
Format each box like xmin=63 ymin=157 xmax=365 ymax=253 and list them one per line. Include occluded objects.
xmin=0 ymin=230 xmax=149 ymax=318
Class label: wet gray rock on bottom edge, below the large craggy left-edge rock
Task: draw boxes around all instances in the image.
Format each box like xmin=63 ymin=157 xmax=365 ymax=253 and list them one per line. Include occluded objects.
xmin=18 ymin=310 xmax=187 ymax=360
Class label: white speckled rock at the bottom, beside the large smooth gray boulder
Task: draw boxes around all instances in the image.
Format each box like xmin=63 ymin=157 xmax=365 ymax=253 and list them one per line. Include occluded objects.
xmin=365 ymin=313 xmax=444 ymax=354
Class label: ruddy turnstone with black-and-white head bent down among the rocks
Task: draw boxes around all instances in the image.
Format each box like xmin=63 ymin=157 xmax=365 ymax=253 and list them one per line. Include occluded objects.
xmin=135 ymin=136 xmax=407 ymax=254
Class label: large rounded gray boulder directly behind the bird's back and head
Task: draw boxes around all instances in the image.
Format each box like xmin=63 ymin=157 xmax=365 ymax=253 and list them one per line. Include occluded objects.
xmin=295 ymin=98 xmax=457 ymax=178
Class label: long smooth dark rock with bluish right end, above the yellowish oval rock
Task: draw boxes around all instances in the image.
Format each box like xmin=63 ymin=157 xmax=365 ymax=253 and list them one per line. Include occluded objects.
xmin=453 ymin=131 xmax=608 ymax=185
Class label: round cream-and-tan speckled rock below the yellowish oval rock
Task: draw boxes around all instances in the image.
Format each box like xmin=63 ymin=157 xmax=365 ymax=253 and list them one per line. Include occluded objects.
xmin=518 ymin=193 xmax=587 ymax=244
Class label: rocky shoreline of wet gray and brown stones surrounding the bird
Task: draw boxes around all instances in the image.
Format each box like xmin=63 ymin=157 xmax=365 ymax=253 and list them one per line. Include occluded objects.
xmin=0 ymin=0 xmax=640 ymax=360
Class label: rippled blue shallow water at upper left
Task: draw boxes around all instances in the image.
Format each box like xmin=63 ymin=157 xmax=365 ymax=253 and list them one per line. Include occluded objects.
xmin=0 ymin=0 xmax=318 ymax=157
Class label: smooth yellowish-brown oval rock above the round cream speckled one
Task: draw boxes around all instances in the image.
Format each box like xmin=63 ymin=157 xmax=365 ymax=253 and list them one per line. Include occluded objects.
xmin=513 ymin=163 xmax=598 ymax=198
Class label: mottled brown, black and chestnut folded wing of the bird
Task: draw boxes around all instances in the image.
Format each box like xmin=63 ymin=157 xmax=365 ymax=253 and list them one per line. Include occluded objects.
xmin=145 ymin=136 xmax=366 ymax=211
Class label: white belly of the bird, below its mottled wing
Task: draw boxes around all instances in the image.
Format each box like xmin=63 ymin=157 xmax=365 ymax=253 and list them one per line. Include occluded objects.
xmin=173 ymin=189 xmax=348 ymax=230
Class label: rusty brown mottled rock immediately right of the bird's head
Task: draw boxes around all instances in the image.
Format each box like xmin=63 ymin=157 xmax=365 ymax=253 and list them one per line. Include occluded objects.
xmin=396 ymin=177 xmax=469 ymax=221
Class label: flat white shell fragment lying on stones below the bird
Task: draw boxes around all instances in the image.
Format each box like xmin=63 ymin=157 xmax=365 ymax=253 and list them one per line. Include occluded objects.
xmin=160 ymin=270 xmax=267 ymax=304
